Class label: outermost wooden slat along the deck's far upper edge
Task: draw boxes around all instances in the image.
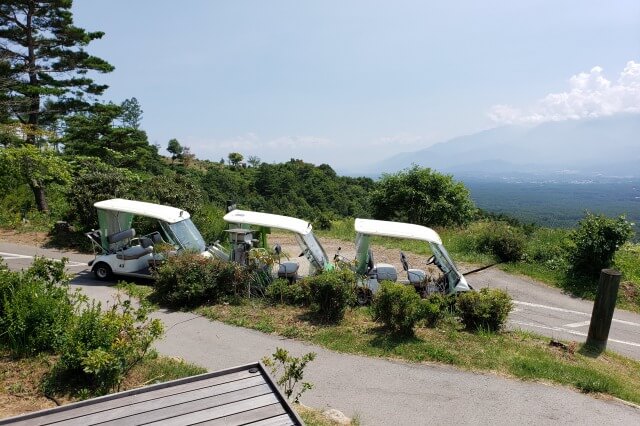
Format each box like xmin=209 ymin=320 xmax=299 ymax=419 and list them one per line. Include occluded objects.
xmin=0 ymin=367 xmax=262 ymax=425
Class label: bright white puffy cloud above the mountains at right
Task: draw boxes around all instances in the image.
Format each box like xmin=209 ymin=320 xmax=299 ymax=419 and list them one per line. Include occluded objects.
xmin=489 ymin=61 xmax=640 ymax=124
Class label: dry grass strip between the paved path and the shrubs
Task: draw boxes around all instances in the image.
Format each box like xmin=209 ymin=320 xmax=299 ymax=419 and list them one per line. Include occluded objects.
xmin=197 ymin=300 xmax=640 ymax=404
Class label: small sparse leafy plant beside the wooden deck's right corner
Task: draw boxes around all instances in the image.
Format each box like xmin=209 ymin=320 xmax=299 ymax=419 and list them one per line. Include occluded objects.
xmin=262 ymin=348 xmax=316 ymax=403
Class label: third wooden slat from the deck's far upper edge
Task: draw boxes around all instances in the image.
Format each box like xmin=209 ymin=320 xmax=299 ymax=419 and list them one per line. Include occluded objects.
xmin=95 ymin=384 xmax=271 ymax=426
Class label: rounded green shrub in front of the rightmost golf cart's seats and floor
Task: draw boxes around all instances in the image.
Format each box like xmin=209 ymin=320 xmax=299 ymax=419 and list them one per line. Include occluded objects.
xmin=371 ymin=282 xmax=422 ymax=335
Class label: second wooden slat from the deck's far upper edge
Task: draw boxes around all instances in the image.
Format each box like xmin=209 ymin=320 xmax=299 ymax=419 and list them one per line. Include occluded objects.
xmin=50 ymin=376 xmax=268 ymax=426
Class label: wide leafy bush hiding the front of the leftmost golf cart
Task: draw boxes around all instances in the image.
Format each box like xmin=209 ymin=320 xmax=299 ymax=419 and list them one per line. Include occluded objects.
xmin=154 ymin=253 xmax=248 ymax=307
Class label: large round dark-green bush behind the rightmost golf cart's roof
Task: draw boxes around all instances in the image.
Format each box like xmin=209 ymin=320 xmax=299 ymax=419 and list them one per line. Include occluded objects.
xmin=371 ymin=166 xmax=475 ymax=227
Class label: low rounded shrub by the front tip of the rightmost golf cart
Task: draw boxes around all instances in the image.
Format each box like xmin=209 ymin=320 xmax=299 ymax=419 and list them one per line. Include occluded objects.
xmin=456 ymin=288 xmax=513 ymax=331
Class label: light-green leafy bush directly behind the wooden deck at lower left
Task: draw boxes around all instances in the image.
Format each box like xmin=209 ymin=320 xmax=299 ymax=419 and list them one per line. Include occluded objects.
xmin=45 ymin=299 xmax=162 ymax=394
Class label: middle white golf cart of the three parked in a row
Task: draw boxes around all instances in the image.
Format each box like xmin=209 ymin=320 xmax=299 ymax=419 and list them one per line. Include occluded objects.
xmin=223 ymin=210 xmax=330 ymax=281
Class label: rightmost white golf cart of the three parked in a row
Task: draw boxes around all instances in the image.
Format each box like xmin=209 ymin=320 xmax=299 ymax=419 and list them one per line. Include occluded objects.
xmin=355 ymin=219 xmax=472 ymax=297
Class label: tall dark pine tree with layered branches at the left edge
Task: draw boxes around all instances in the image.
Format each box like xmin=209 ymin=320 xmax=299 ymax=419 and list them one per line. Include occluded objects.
xmin=0 ymin=0 xmax=113 ymax=211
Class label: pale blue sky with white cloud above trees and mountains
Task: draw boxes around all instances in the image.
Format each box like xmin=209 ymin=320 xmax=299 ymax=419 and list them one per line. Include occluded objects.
xmin=73 ymin=0 xmax=640 ymax=170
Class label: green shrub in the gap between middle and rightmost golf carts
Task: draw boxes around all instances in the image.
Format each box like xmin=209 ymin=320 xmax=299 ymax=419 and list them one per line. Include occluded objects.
xmin=304 ymin=271 xmax=355 ymax=322
